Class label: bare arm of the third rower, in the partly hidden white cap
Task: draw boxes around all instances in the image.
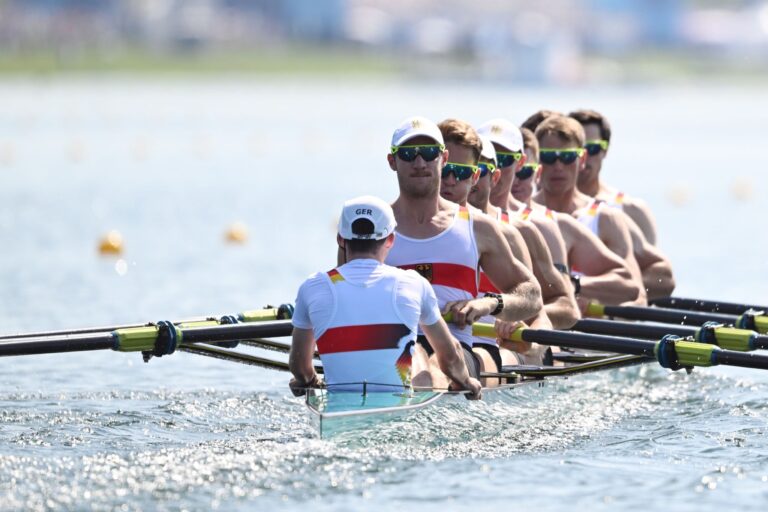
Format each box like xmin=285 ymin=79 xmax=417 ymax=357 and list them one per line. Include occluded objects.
xmin=518 ymin=222 xmax=581 ymax=329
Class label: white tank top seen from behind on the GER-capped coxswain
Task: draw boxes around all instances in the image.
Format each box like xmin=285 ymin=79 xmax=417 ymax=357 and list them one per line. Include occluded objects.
xmin=315 ymin=266 xmax=426 ymax=391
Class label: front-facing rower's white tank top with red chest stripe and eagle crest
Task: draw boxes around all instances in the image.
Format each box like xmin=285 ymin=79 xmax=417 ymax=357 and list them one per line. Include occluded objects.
xmin=386 ymin=205 xmax=480 ymax=346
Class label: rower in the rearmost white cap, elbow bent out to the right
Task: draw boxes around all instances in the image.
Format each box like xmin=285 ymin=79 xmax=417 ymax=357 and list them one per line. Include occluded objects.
xmin=479 ymin=119 xmax=640 ymax=311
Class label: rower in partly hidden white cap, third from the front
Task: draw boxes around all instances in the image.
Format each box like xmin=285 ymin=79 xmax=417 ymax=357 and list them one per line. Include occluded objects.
xmin=462 ymin=129 xmax=581 ymax=329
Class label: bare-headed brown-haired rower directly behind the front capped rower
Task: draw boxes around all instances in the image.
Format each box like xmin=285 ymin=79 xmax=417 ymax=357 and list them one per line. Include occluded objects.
xmin=438 ymin=119 xmax=556 ymax=378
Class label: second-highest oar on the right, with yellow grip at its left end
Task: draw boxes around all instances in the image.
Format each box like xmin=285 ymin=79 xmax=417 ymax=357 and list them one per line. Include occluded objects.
xmin=587 ymin=303 xmax=768 ymax=334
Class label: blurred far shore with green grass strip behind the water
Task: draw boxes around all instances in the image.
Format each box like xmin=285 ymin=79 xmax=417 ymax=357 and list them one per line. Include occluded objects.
xmin=0 ymin=0 xmax=768 ymax=85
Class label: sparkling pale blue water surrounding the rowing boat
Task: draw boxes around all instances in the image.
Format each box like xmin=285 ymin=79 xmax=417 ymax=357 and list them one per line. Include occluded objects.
xmin=0 ymin=78 xmax=768 ymax=510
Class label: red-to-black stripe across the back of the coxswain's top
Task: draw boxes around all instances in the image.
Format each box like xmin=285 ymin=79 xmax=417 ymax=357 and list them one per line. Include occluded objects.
xmin=317 ymin=324 xmax=411 ymax=354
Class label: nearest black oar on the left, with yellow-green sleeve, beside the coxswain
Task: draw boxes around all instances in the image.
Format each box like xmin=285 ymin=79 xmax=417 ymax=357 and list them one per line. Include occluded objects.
xmin=0 ymin=320 xmax=293 ymax=358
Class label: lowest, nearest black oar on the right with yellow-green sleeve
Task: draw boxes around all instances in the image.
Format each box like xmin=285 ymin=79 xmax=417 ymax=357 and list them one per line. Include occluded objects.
xmin=472 ymin=324 xmax=768 ymax=370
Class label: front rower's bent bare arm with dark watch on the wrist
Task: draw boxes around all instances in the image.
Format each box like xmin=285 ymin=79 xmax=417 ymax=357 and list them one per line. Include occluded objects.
xmin=474 ymin=216 xmax=543 ymax=321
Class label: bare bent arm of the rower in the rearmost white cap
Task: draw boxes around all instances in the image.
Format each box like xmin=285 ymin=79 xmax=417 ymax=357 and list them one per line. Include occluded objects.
xmin=558 ymin=215 xmax=640 ymax=305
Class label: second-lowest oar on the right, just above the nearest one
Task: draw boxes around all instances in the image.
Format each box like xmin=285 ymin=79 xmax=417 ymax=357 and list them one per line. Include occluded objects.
xmin=571 ymin=318 xmax=768 ymax=352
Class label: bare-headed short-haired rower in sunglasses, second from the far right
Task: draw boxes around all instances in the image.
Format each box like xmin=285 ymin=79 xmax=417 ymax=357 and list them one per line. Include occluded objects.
xmin=534 ymin=116 xmax=674 ymax=304
